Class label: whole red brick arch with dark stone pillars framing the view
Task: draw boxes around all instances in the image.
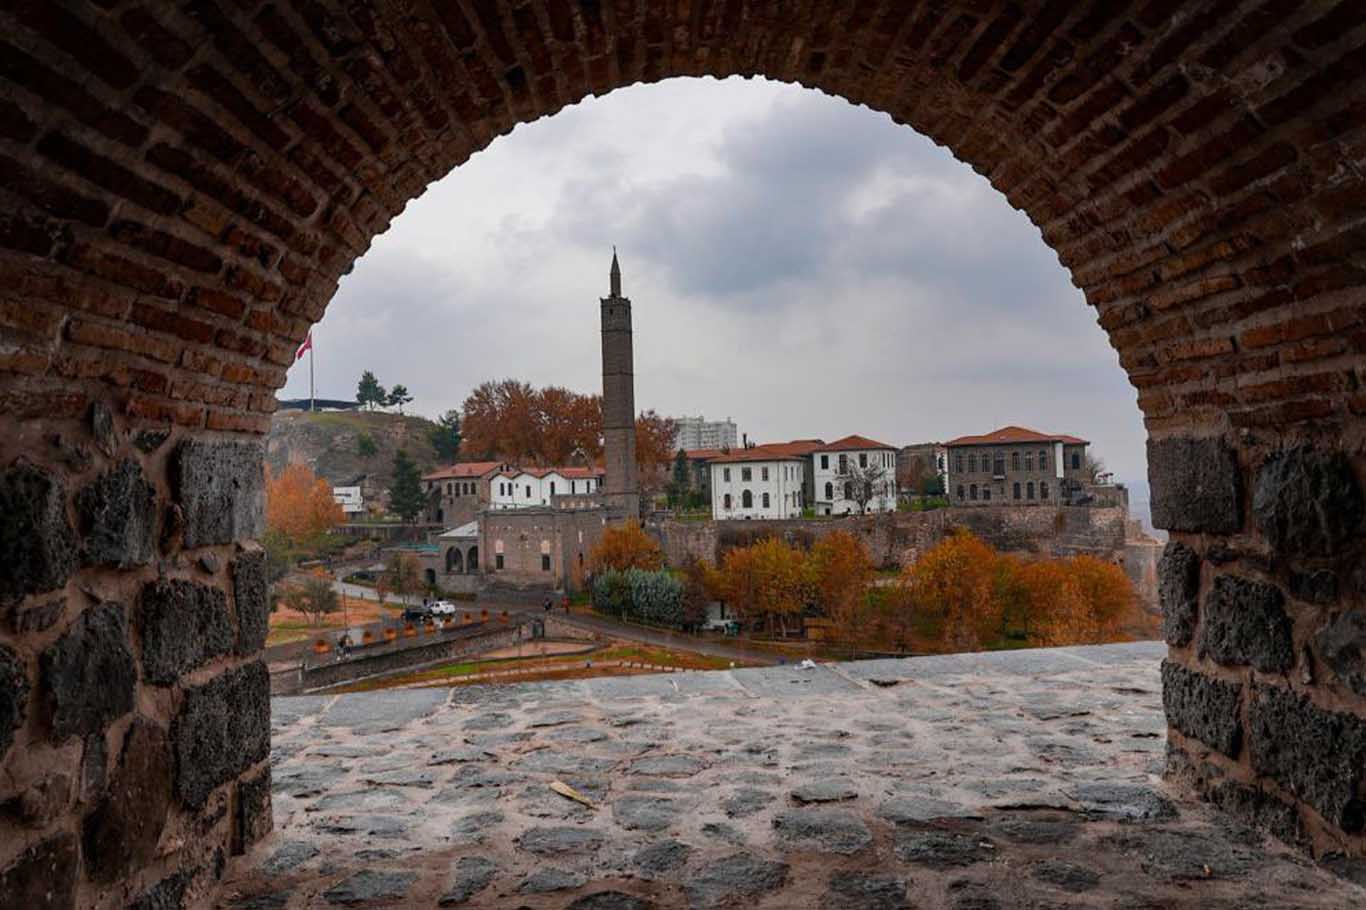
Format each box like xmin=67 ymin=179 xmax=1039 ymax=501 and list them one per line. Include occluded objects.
xmin=0 ymin=0 xmax=1366 ymax=903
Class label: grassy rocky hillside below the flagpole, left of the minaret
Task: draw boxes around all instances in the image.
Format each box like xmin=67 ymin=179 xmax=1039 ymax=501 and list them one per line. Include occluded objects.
xmin=266 ymin=411 xmax=438 ymax=513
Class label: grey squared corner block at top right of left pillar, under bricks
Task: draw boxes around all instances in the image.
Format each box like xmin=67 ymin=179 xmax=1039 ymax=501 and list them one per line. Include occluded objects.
xmin=171 ymin=440 xmax=265 ymax=548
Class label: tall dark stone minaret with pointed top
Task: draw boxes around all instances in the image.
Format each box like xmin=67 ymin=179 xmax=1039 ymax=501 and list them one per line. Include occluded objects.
xmin=602 ymin=246 xmax=641 ymax=518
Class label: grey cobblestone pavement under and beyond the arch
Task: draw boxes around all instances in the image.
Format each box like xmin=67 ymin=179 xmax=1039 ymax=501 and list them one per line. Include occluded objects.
xmin=219 ymin=645 xmax=1366 ymax=910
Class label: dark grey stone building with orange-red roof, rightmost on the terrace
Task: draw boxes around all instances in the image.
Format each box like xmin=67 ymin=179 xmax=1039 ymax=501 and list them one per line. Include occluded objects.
xmin=945 ymin=426 xmax=1090 ymax=506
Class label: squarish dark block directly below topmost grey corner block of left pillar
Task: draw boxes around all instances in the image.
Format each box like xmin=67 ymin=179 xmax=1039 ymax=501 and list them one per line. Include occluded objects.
xmin=141 ymin=579 xmax=232 ymax=686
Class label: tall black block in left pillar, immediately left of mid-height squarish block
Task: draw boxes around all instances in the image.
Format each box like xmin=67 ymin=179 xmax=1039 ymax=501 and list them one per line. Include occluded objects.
xmin=40 ymin=604 xmax=138 ymax=739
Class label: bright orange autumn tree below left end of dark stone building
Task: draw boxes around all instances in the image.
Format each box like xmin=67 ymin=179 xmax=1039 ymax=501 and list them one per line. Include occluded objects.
xmin=907 ymin=532 xmax=1000 ymax=650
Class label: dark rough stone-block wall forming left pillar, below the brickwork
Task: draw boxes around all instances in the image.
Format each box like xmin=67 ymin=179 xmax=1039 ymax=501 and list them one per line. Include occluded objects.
xmin=0 ymin=399 xmax=270 ymax=907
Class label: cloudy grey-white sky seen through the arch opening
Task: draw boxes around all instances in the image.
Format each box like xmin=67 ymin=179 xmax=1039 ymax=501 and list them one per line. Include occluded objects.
xmin=280 ymin=79 xmax=1146 ymax=516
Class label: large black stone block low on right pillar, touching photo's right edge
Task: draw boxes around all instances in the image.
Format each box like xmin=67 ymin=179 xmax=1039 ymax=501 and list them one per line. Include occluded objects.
xmin=1247 ymin=686 xmax=1366 ymax=833
